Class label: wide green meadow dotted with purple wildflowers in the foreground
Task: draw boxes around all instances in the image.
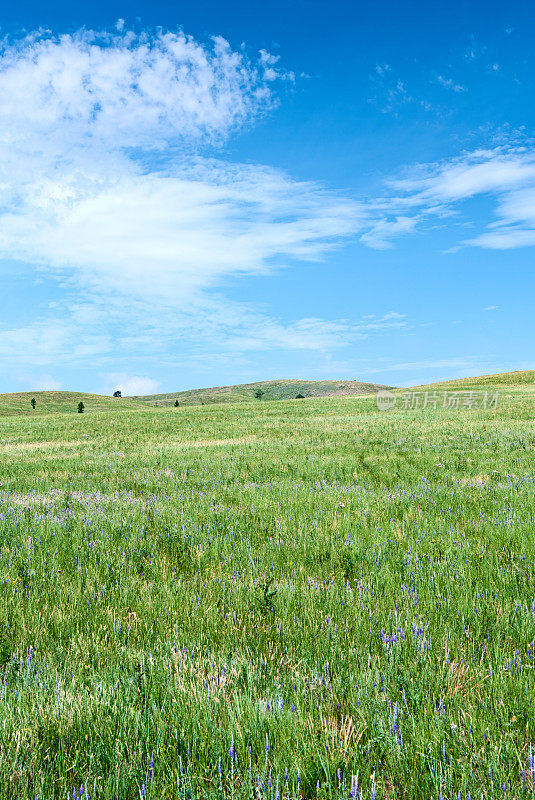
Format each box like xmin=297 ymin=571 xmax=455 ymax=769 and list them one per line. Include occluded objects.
xmin=0 ymin=384 xmax=535 ymax=800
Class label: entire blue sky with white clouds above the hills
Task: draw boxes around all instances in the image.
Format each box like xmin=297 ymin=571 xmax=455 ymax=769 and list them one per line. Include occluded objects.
xmin=0 ymin=0 xmax=535 ymax=393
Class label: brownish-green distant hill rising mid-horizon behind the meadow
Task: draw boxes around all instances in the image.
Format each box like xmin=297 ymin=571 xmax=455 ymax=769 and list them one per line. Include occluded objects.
xmin=133 ymin=380 xmax=392 ymax=405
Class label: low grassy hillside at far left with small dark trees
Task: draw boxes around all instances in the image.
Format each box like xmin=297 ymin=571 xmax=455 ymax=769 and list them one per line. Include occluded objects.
xmin=0 ymin=391 xmax=144 ymax=417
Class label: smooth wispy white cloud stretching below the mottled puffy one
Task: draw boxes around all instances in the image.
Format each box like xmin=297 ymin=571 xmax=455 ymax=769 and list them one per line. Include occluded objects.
xmin=0 ymin=160 xmax=362 ymax=304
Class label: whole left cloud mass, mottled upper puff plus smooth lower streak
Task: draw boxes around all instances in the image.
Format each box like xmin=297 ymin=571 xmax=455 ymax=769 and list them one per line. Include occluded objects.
xmin=0 ymin=25 xmax=364 ymax=304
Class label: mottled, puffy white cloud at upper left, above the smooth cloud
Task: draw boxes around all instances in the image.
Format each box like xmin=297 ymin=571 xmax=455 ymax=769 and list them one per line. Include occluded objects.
xmin=0 ymin=26 xmax=282 ymax=159
